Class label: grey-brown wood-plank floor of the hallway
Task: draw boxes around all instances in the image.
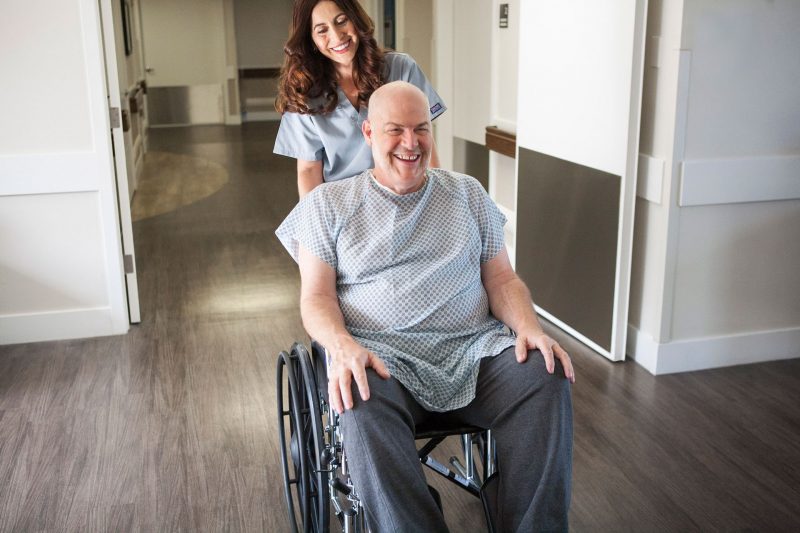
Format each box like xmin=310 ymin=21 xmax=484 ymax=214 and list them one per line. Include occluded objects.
xmin=0 ymin=123 xmax=800 ymax=532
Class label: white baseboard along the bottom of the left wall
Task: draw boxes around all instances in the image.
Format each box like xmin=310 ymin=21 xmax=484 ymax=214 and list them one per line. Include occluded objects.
xmin=0 ymin=307 xmax=129 ymax=344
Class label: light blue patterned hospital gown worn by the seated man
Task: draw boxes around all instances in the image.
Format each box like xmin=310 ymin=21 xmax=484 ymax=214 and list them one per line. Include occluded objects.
xmin=276 ymin=169 xmax=514 ymax=411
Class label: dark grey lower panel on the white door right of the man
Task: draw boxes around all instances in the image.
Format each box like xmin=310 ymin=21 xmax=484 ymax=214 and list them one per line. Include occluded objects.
xmin=516 ymin=146 xmax=620 ymax=350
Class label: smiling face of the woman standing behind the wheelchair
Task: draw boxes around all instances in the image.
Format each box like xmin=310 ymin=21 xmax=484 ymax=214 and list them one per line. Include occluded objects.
xmin=311 ymin=0 xmax=358 ymax=68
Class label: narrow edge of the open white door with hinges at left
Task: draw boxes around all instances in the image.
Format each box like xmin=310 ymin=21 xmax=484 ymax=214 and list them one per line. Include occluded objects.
xmin=99 ymin=0 xmax=142 ymax=324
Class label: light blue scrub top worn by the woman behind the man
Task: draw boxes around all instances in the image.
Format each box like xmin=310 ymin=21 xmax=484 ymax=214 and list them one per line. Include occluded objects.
xmin=273 ymin=52 xmax=447 ymax=181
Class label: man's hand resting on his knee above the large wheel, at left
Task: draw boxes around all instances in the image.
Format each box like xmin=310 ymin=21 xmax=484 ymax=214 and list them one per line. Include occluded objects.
xmin=328 ymin=338 xmax=390 ymax=415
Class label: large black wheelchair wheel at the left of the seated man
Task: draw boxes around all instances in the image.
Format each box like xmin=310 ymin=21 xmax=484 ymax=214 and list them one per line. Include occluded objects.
xmin=277 ymin=344 xmax=330 ymax=532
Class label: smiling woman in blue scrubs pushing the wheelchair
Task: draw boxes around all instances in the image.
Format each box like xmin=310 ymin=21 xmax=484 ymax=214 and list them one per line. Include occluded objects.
xmin=274 ymin=0 xmax=446 ymax=198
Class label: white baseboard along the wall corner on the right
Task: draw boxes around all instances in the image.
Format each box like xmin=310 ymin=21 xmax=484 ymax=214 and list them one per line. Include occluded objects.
xmin=627 ymin=324 xmax=800 ymax=375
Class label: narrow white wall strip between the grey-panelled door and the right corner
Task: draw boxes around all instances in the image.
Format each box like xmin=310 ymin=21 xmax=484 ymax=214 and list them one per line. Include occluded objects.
xmin=628 ymin=0 xmax=687 ymax=340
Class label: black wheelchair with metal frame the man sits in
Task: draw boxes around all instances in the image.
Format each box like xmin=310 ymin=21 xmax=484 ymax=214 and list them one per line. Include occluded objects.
xmin=276 ymin=341 xmax=496 ymax=533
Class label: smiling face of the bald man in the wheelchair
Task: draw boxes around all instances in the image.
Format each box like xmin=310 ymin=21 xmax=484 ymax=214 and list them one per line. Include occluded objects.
xmin=364 ymin=91 xmax=433 ymax=194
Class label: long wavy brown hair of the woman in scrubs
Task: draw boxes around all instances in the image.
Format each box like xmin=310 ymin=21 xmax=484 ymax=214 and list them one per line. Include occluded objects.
xmin=275 ymin=0 xmax=385 ymax=115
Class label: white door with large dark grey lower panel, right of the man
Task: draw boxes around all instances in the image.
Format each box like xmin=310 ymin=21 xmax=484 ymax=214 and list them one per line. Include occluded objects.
xmin=516 ymin=0 xmax=646 ymax=361
